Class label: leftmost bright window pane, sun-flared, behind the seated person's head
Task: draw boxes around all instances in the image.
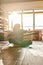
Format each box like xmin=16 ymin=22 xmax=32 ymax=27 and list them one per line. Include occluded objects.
xmin=8 ymin=12 xmax=21 ymax=30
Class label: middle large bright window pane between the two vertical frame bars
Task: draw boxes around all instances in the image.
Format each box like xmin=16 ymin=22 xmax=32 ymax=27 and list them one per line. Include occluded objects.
xmin=23 ymin=14 xmax=33 ymax=30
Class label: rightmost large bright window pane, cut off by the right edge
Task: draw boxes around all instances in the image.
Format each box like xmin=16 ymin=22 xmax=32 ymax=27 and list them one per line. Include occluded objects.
xmin=35 ymin=13 xmax=43 ymax=29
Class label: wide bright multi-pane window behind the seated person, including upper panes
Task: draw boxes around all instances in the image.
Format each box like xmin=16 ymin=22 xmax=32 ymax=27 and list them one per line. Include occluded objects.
xmin=8 ymin=10 xmax=43 ymax=30
